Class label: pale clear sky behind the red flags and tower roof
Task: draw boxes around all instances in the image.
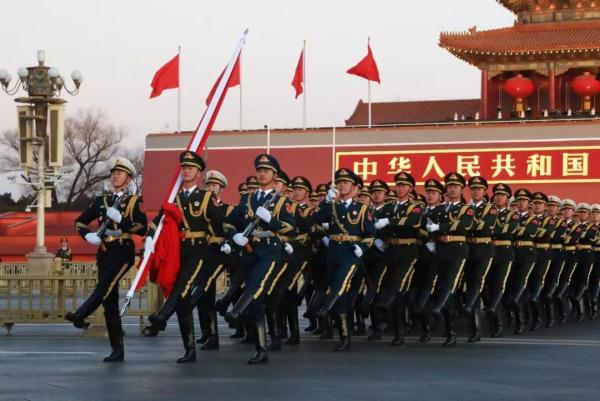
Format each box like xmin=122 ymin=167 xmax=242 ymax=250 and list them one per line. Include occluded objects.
xmin=0 ymin=0 xmax=515 ymax=148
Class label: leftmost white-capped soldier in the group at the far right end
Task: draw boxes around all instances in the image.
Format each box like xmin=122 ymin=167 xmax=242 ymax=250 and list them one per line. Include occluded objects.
xmin=555 ymin=199 xmax=581 ymax=325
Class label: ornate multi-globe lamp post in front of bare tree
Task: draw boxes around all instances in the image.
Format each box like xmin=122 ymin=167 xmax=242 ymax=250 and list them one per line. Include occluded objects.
xmin=0 ymin=50 xmax=83 ymax=270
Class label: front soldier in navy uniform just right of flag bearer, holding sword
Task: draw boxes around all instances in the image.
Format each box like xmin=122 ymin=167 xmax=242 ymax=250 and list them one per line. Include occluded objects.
xmin=223 ymin=154 xmax=294 ymax=365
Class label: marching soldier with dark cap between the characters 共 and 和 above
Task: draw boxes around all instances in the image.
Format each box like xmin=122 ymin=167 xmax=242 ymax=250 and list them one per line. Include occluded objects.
xmin=507 ymin=189 xmax=540 ymax=334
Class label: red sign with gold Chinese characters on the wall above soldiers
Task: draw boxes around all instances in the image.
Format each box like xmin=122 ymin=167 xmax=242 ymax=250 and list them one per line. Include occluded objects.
xmin=336 ymin=146 xmax=600 ymax=184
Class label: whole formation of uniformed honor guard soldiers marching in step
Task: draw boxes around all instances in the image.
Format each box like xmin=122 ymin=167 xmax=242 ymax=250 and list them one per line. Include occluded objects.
xmin=66 ymin=151 xmax=600 ymax=364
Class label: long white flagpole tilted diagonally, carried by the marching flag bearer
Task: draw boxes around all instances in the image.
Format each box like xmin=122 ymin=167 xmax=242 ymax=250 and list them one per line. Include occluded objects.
xmin=120 ymin=29 xmax=248 ymax=316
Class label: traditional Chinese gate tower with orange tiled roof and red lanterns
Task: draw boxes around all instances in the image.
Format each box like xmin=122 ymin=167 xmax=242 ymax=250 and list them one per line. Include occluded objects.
xmin=440 ymin=0 xmax=600 ymax=119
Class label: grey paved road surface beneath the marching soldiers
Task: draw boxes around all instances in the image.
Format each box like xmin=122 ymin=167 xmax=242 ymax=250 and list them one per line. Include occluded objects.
xmin=0 ymin=319 xmax=600 ymax=401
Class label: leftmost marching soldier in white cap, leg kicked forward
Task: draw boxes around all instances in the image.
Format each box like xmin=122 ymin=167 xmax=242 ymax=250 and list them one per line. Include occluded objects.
xmin=65 ymin=157 xmax=147 ymax=362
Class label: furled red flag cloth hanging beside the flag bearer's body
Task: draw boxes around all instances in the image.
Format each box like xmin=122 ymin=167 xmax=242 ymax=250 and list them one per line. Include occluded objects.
xmin=136 ymin=201 xmax=183 ymax=298
